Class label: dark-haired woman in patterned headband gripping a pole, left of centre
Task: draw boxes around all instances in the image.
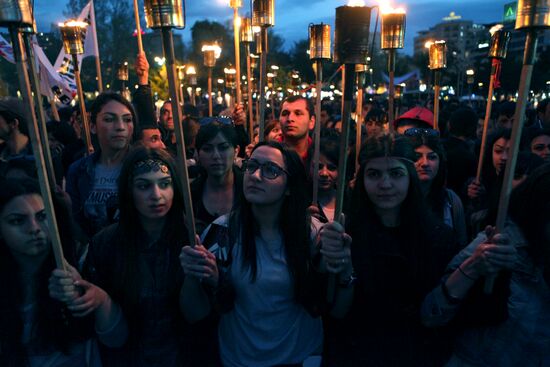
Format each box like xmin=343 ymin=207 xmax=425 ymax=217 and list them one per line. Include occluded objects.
xmin=49 ymin=147 xmax=196 ymax=366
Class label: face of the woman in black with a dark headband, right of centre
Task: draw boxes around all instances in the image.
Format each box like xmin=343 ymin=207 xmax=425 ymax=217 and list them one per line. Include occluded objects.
xmin=363 ymin=157 xmax=410 ymax=210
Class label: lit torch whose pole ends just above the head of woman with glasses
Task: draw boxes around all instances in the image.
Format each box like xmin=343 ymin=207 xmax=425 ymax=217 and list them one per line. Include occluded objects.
xmin=252 ymin=0 xmax=275 ymax=141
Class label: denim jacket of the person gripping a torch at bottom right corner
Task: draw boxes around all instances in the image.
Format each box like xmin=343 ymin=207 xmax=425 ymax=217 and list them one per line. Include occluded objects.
xmin=422 ymin=222 xmax=550 ymax=367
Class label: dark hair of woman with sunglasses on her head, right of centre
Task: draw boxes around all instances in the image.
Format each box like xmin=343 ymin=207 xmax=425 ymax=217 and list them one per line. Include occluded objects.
xmin=409 ymin=135 xmax=447 ymax=218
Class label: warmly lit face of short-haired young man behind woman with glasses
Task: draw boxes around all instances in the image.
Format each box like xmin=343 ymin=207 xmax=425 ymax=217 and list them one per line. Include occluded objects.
xmin=279 ymin=99 xmax=315 ymax=140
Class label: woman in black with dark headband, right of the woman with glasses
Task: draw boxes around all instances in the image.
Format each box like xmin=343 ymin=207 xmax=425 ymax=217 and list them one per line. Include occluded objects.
xmin=327 ymin=136 xmax=464 ymax=367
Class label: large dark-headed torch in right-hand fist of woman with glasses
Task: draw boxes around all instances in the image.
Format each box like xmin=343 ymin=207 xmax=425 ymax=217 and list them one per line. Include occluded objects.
xmin=327 ymin=0 xmax=372 ymax=303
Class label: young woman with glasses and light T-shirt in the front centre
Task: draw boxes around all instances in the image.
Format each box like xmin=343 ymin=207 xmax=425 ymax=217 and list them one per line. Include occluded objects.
xmin=180 ymin=142 xmax=351 ymax=366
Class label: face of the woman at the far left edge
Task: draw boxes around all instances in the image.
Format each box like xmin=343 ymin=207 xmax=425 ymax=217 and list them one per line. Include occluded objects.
xmin=0 ymin=194 xmax=50 ymax=260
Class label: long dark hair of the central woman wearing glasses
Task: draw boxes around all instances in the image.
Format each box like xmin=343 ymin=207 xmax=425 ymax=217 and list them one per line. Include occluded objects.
xmin=229 ymin=142 xmax=311 ymax=302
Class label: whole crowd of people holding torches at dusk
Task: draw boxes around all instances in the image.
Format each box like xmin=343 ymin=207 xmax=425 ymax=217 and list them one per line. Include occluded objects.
xmin=0 ymin=49 xmax=550 ymax=367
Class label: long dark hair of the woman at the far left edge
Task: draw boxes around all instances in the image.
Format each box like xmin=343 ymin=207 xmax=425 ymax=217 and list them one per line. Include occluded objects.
xmin=0 ymin=178 xmax=89 ymax=366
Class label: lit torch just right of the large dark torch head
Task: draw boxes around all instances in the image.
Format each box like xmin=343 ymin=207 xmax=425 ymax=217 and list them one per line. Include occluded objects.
xmin=380 ymin=3 xmax=405 ymax=129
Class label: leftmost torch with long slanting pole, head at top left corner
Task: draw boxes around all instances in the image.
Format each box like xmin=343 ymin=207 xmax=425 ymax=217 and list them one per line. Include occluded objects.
xmin=0 ymin=0 xmax=65 ymax=270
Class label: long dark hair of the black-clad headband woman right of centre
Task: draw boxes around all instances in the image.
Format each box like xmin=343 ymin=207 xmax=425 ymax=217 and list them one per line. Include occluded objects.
xmin=348 ymin=135 xmax=436 ymax=282
